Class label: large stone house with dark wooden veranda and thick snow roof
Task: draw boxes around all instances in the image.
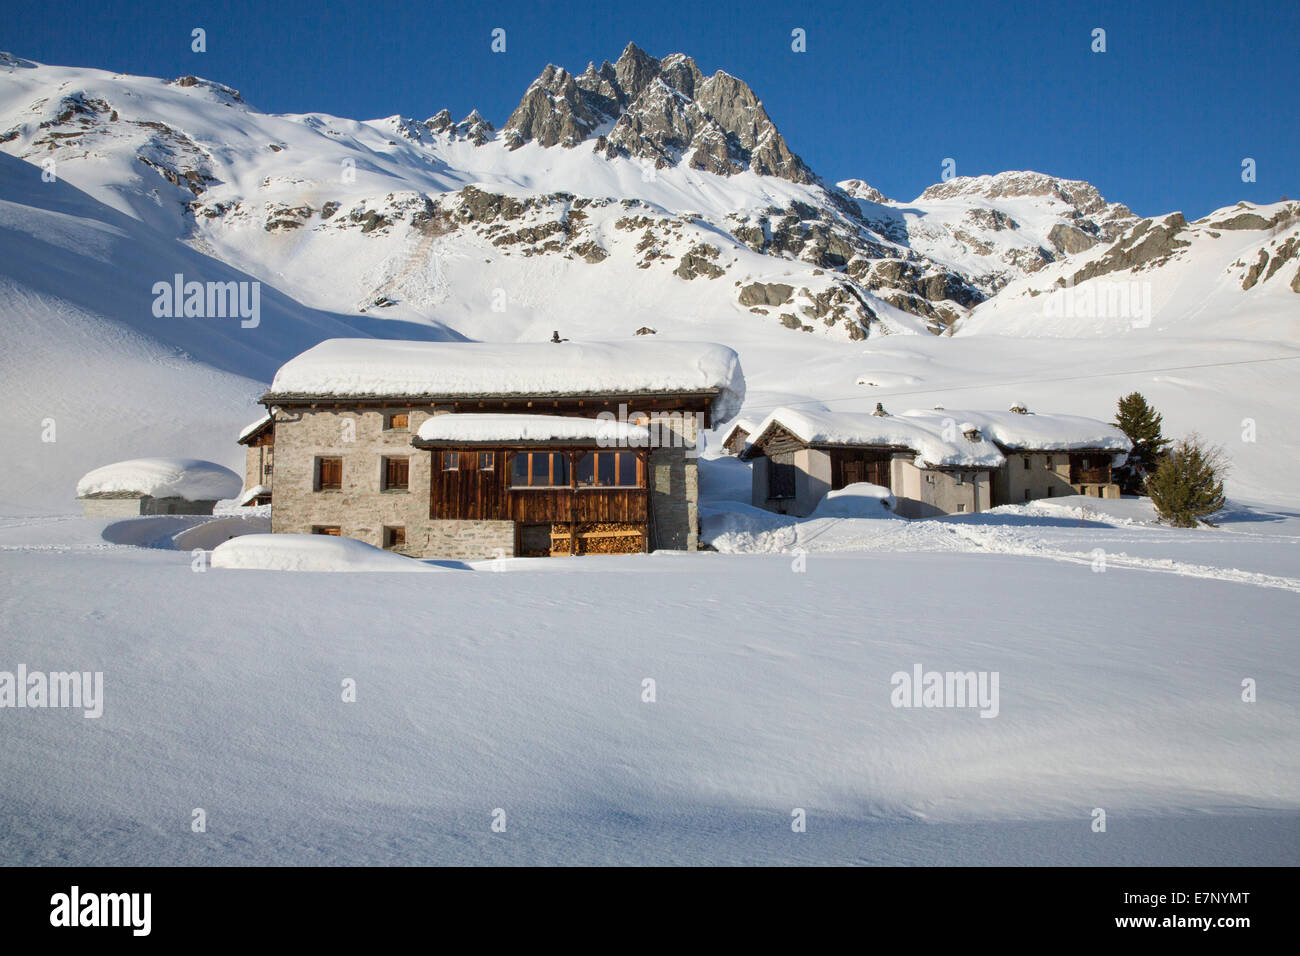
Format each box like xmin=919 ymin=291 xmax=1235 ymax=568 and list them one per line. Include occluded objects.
xmin=260 ymin=338 xmax=745 ymax=559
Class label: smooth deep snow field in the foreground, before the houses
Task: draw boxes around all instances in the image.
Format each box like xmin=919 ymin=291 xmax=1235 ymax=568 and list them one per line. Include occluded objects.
xmin=0 ymin=494 xmax=1300 ymax=865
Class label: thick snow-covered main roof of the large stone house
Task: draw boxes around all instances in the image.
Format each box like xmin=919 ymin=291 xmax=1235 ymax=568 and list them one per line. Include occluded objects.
xmin=267 ymin=338 xmax=745 ymax=420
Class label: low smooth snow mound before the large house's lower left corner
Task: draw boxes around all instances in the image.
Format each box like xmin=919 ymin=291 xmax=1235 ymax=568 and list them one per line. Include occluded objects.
xmin=212 ymin=535 xmax=434 ymax=571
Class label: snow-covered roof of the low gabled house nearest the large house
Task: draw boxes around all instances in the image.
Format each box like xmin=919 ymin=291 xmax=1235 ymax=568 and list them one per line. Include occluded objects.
xmin=750 ymin=407 xmax=1006 ymax=468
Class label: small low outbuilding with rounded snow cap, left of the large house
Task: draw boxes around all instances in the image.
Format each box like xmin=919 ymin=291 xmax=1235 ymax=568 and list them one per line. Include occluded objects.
xmin=77 ymin=458 xmax=241 ymax=518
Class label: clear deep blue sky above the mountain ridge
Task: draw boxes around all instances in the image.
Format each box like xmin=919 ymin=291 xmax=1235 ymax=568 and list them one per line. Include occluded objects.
xmin=10 ymin=0 xmax=1300 ymax=217
